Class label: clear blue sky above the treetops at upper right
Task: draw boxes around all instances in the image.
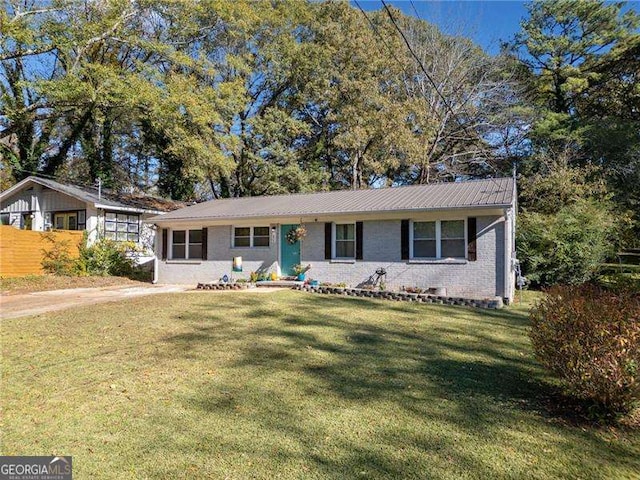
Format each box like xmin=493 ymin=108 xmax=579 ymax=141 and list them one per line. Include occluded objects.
xmin=352 ymin=0 xmax=640 ymax=54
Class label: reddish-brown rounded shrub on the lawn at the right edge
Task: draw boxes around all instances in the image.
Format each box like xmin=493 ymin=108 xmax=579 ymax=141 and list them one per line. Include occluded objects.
xmin=530 ymin=285 xmax=640 ymax=413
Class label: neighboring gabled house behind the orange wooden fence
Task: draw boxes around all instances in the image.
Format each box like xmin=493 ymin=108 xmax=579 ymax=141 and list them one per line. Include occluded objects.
xmin=0 ymin=176 xmax=185 ymax=256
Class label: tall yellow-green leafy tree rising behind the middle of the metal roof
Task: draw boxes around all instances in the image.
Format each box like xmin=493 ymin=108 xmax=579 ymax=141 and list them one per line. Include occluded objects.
xmin=299 ymin=2 xmax=411 ymax=188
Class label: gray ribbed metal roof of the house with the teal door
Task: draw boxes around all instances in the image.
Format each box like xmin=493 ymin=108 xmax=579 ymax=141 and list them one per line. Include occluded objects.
xmin=149 ymin=178 xmax=515 ymax=223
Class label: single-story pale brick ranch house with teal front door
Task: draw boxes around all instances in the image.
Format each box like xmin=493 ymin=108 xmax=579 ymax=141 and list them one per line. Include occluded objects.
xmin=149 ymin=178 xmax=516 ymax=301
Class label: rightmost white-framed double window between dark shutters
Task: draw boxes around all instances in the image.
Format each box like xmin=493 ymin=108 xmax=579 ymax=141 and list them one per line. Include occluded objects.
xmin=409 ymin=220 xmax=467 ymax=259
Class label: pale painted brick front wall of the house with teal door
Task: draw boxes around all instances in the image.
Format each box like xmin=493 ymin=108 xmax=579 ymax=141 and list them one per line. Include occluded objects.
xmin=158 ymin=216 xmax=506 ymax=298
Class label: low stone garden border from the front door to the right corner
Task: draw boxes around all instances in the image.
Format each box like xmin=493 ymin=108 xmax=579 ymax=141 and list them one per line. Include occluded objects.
xmin=293 ymin=285 xmax=503 ymax=310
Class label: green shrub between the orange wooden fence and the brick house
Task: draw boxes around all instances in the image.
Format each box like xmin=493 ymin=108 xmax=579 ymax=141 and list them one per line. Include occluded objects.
xmin=78 ymin=238 xmax=135 ymax=276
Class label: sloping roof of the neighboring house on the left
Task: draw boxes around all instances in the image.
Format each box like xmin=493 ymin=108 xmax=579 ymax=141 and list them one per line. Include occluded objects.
xmin=0 ymin=176 xmax=187 ymax=213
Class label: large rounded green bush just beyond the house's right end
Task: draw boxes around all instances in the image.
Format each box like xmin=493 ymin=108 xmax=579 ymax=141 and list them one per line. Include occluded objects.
xmin=516 ymin=199 xmax=619 ymax=286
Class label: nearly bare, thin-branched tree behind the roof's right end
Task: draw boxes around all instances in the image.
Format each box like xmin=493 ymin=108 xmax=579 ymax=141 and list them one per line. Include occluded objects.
xmin=401 ymin=13 xmax=530 ymax=183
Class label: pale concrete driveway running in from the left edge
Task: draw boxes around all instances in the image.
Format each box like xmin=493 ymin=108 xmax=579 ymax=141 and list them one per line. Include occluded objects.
xmin=0 ymin=285 xmax=193 ymax=319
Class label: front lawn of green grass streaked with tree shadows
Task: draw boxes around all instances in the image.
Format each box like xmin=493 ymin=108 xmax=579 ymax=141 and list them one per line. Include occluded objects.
xmin=0 ymin=291 xmax=640 ymax=480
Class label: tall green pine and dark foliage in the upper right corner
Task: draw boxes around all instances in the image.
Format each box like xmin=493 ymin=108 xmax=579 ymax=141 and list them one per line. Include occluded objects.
xmin=510 ymin=0 xmax=640 ymax=246
